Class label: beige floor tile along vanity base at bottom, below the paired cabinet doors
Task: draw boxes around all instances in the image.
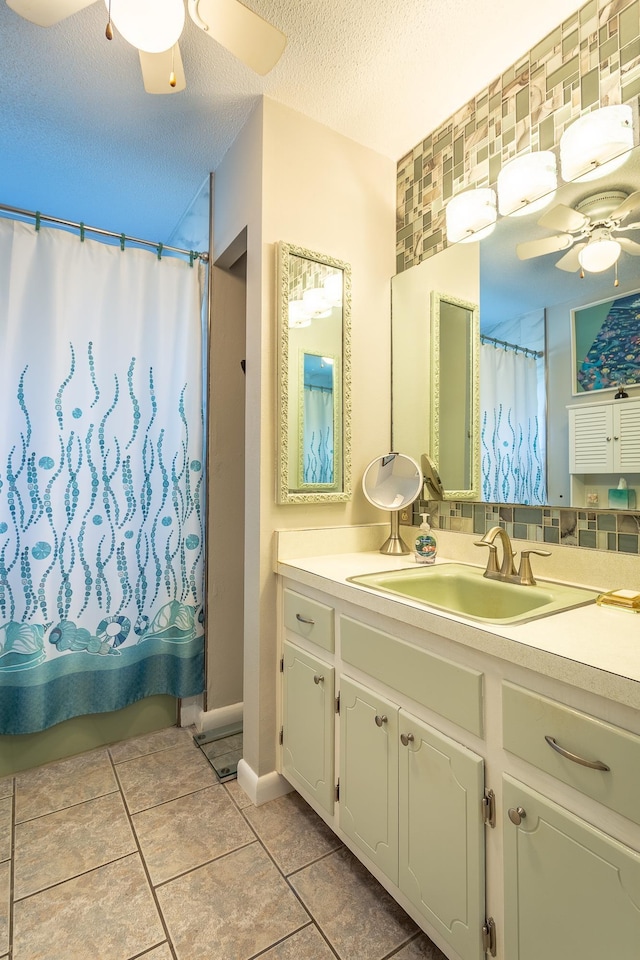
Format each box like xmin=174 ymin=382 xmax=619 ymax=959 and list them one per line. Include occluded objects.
xmin=290 ymin=847 xmax=418 ymax=960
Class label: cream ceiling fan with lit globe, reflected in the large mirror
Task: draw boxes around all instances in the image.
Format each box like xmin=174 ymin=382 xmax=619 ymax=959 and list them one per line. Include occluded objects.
xmin=516 ymin=190 xmax=640 ymax=273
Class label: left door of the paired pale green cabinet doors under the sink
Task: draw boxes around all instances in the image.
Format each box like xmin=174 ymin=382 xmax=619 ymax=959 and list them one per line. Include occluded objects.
xmin=340 ymin=677 xmax=398 ymax=883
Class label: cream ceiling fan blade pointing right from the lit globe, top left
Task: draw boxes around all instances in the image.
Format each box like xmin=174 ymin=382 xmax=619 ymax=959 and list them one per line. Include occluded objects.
xmin=189 ymin=0 xmax=287 ymax=76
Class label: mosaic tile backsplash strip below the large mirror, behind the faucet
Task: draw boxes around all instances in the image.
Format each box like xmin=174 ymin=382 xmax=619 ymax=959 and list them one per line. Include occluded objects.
xmin=412 ymin=500 xmax=640 ymax=554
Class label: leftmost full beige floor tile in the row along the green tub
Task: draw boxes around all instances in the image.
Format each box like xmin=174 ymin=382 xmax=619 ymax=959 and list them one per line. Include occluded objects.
xmin=16 ymin=750 xmax=118 ymax=823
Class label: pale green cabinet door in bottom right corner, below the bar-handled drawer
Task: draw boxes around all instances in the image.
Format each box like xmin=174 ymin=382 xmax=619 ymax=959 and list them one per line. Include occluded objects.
xmin=503 ymin=774 xmax=640 ymax=960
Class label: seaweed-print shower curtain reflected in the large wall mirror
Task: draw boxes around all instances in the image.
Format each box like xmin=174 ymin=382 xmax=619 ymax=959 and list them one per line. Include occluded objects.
xmin=480 ymin=344 xmax=547 ymax=504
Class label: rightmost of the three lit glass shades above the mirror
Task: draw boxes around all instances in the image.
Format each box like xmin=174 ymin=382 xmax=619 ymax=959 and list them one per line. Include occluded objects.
xmin=560 ymin=104 xmax=633 ymax=183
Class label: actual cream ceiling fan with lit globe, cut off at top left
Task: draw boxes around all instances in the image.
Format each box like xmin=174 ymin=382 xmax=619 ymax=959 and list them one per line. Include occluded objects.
xmin=6 ymin=0 xmax=287 ymax=93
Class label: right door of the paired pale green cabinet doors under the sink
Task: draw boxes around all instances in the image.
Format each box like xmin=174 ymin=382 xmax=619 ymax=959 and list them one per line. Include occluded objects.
xmin=398 ymin=710 xmax=482 ymax=960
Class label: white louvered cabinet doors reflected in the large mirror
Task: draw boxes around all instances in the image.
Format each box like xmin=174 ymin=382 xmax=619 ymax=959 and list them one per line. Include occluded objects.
xmin=568 ymin=397 xmax=640 ymax=474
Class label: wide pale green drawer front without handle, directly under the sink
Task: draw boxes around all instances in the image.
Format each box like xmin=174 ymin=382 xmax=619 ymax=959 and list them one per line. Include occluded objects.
xmin=340 ymin=617 xmax=483 ymax=736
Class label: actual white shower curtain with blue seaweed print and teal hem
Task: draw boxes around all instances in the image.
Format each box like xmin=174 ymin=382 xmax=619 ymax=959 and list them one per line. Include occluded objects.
xmin=0 ymin=220 xmax=204 ymax=734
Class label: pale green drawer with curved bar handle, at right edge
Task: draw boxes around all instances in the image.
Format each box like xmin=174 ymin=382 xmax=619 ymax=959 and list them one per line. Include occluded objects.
xmin=502 ymin=681 xmax=640 ymax=823
